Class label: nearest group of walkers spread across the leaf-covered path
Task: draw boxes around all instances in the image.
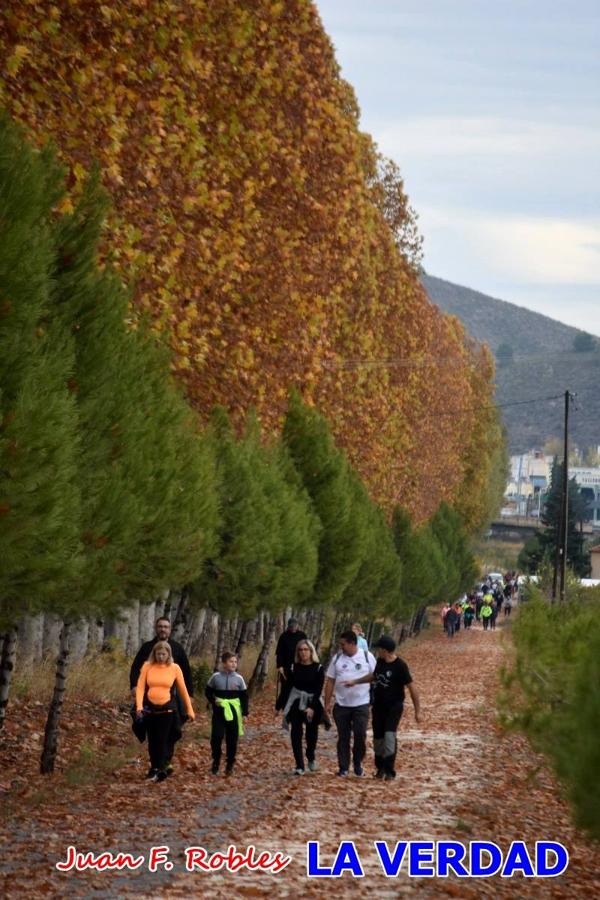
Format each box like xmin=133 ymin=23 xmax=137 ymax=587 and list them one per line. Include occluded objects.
xmin=130 ymin=617 xmax=420 ymax=781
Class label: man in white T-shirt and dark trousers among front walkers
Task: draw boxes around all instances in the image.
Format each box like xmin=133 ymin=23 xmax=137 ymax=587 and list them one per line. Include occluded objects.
xmin=325 ymin=631 xmax=375 ymax=777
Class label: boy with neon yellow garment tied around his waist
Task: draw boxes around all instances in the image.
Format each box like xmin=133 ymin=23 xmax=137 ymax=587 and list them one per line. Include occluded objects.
xmin=204 ymin=651 xmax=248 ymax=775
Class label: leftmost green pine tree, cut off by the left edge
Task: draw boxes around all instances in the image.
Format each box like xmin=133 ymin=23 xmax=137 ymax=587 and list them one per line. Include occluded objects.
xmin=0 ymin=117 xmax=80 ymax=727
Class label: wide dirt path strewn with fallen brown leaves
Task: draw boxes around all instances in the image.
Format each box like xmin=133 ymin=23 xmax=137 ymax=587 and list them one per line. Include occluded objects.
xmin=0 ymin=625 xmax=600 ymax=898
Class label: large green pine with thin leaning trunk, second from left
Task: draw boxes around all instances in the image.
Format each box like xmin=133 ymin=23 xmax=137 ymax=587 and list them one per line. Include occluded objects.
xmin=42 ymin=167 xmax=217 ymax=772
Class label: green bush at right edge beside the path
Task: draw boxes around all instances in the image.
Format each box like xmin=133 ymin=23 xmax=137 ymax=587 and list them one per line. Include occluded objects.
xmin=501 ymin=588 xmax=600 ymax=840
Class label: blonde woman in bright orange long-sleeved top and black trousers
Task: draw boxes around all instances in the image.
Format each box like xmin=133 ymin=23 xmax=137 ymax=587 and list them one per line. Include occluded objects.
xmin=135 ymin=641 xmax=196 ymax=781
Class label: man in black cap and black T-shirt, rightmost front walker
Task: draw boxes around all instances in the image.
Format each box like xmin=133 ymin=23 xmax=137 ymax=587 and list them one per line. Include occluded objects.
xmin=344 ymin=634 xmax=421 ymax=781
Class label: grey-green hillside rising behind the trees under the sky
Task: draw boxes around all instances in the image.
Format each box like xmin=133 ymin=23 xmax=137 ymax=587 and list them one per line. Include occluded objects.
xmin=421 ymin=274 xmax=600 ymax=453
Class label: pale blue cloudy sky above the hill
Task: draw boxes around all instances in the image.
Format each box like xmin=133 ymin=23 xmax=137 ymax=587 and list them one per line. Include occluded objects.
xmin=316 ymin=0 xmax=600 ymax=335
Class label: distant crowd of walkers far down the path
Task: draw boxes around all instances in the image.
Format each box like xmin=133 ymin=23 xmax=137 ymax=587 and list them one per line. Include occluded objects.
xmin=440 ymin=572 xmax=518 ymax=638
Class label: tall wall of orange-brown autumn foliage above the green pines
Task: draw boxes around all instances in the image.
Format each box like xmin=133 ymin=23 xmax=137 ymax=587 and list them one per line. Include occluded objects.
xmin=0 ymin=0 xmax=496 ymax=527
